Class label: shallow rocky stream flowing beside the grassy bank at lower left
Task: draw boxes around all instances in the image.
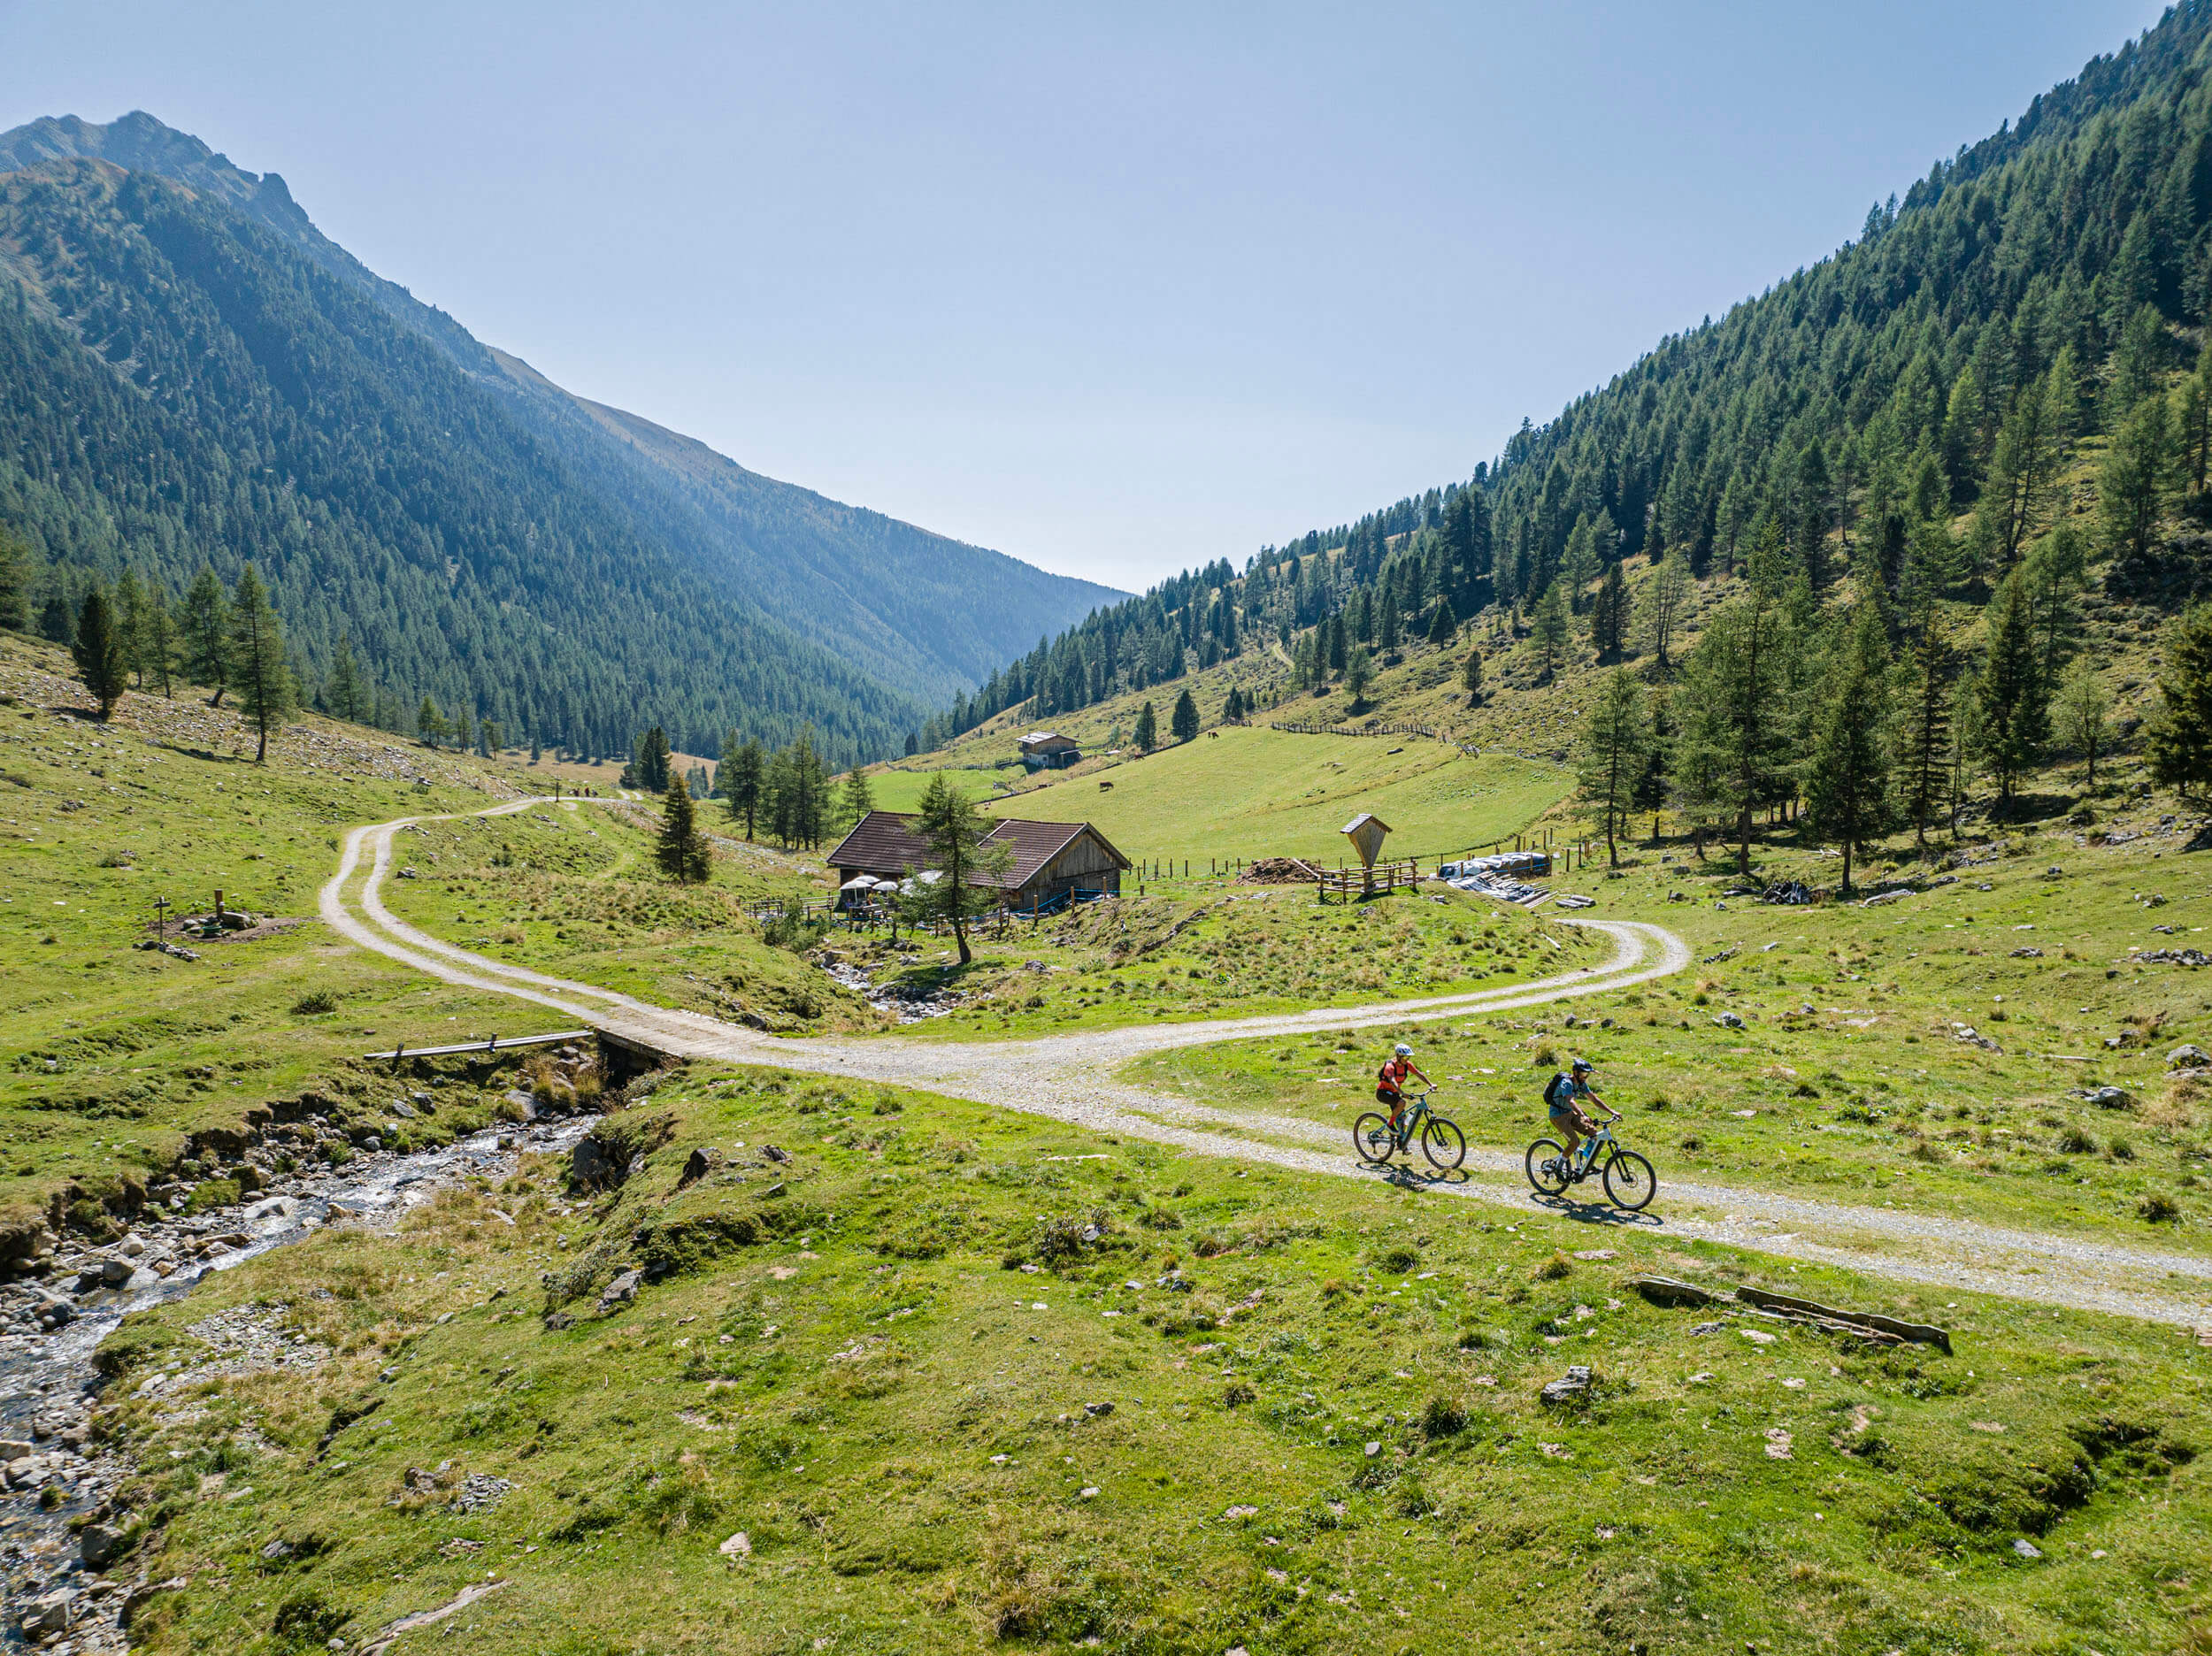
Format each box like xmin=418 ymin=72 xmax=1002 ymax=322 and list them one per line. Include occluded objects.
xmin=0 ymin=1115 xmax=597 ymax=1656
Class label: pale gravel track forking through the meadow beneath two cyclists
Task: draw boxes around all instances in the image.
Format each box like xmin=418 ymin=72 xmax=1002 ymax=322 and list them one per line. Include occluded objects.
xmin=321 ymin=798 xmax=2212 ymax=1329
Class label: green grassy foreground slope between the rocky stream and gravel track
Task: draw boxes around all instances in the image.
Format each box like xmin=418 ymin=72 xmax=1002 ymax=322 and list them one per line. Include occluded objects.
xmin=106 ymin=1066 xmax=2212 ymax=1656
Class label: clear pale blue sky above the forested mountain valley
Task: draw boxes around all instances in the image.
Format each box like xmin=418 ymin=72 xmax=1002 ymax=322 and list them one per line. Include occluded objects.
xmin=0 ymin=0 xmax=2159 ymax=588
